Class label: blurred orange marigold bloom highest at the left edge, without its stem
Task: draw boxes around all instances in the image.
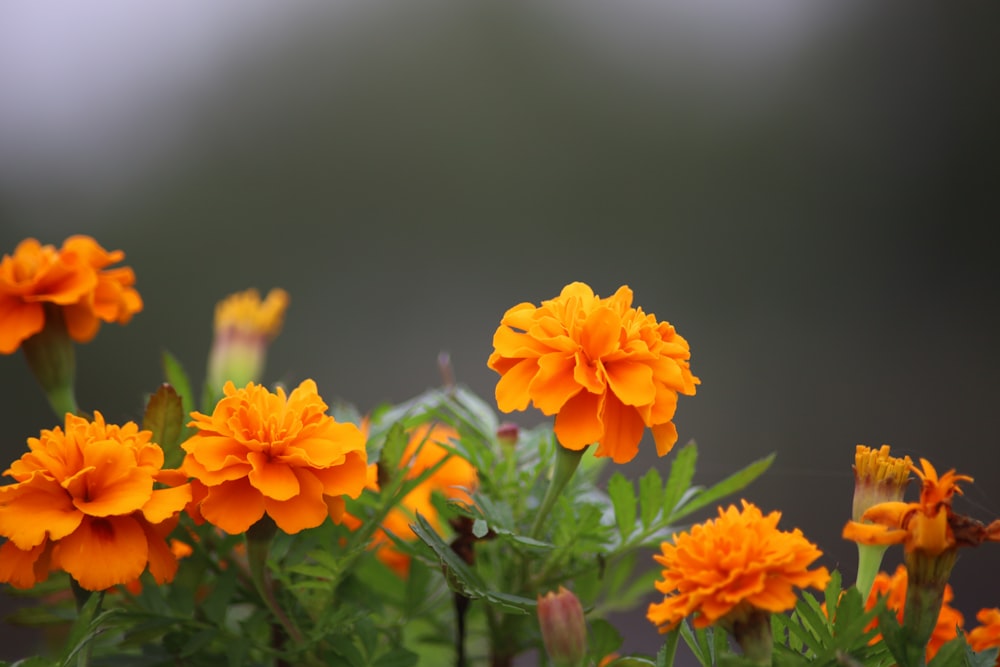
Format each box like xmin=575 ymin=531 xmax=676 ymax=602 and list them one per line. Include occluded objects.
xmin=0 ymin=236 xmax=142 ymax=354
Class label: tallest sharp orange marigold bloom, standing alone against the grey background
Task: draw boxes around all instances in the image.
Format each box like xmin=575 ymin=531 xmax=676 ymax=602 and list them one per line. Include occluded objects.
xmin=488 ymin=282 xmax=700 ymax=463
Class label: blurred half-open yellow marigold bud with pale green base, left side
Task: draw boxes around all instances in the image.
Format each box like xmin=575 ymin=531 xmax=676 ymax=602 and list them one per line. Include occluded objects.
xmin=208 ymin=288 xmax=288 ymax=392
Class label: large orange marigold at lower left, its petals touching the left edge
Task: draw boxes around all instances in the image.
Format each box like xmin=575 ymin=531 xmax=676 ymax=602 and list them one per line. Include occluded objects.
xmin=0 ymin=412 xmax=191 ymax=590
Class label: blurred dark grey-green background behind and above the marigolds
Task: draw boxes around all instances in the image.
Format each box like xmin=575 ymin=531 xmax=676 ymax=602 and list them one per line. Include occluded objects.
xmin=0 ymin=0 xmax=1000 ymax=658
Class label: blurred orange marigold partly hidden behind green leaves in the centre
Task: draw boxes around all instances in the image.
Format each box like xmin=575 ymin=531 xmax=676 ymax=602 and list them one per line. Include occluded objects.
xmin=352 ymin=424 xmax=477 ymax=577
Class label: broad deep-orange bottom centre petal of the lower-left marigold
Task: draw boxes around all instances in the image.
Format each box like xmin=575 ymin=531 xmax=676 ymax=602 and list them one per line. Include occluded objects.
xmin=53 ymin=516 xmax=149 ymax=591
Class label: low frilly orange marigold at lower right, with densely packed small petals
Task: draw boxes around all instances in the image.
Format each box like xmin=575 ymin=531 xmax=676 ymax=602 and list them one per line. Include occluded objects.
xmin=646 ymin=500 xmax=830 ymax=632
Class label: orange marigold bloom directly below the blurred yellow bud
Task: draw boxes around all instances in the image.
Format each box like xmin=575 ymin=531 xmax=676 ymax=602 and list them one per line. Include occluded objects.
xmin=181 ymin=380 xmax=367 ymax=534
